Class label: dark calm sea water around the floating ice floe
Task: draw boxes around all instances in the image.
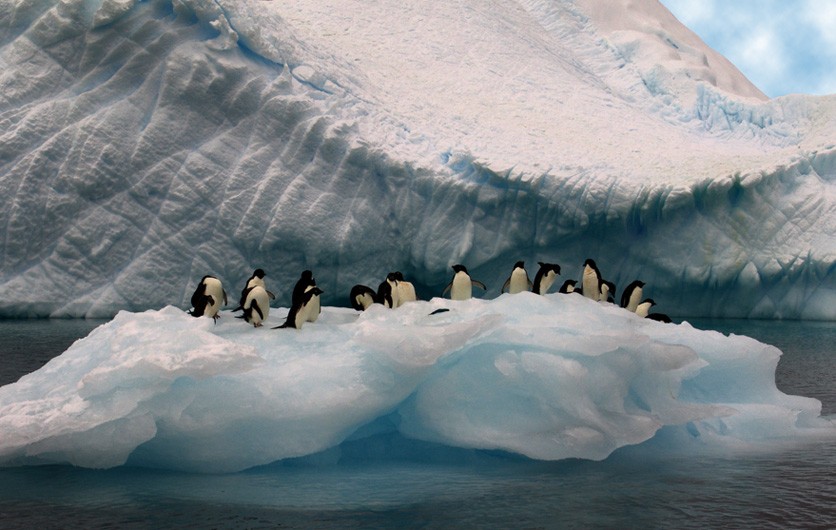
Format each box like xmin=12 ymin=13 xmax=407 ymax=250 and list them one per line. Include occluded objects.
xmin=0 ymin=320 xmax=836 ymax=529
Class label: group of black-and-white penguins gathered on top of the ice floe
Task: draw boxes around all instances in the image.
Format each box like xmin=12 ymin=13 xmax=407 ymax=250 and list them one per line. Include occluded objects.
xmin=189 ymin=259 xmax=671 ymax=329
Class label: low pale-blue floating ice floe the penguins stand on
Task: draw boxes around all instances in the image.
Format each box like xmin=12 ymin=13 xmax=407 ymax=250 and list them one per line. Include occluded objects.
xmin=0 ymin=293 xmax=836 ymax=472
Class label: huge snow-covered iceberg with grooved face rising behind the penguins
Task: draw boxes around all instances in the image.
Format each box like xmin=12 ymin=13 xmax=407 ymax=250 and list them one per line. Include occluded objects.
xmin=0 ymin=0 xmax=836 ymax=319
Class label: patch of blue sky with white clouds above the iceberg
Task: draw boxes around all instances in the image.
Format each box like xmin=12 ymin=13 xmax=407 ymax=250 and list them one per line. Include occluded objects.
xmin=660 ymin=0 xmax=836 ymax=97
